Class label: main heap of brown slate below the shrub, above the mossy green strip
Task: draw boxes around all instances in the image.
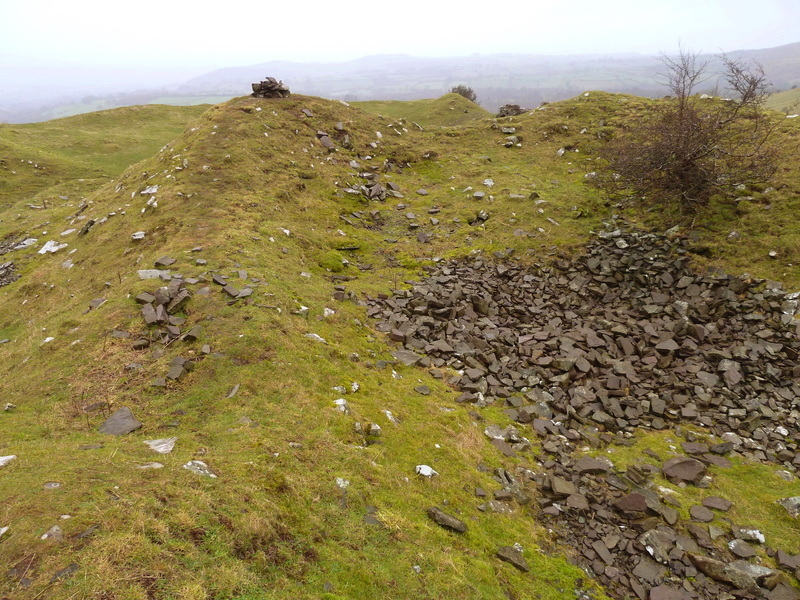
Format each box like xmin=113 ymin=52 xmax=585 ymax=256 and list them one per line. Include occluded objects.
xmin=369 ymin=231 xmax=800 ymax=467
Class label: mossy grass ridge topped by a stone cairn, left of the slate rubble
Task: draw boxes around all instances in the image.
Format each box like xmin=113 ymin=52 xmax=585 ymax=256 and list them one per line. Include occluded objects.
xmin=0 ymin=97 xmax=604 ymax=599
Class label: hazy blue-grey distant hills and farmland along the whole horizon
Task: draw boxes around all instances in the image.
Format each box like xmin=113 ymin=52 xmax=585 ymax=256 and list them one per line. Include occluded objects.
xmin=0 ymin=42 xmax=800 ymax=123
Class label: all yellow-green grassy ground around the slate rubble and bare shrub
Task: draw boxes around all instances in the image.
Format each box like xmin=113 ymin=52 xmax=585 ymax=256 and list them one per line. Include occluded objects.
xmin=0 ymin=92 xmax=800 ymax=600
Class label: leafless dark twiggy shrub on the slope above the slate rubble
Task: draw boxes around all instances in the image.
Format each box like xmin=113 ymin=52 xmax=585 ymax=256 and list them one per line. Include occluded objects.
xmin=593 ymin=49 xmax=779 ymax=212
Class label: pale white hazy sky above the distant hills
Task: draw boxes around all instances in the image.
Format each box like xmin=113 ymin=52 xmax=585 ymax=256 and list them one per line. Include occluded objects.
xmin=0 ymin=0 xmax=800 ymax=68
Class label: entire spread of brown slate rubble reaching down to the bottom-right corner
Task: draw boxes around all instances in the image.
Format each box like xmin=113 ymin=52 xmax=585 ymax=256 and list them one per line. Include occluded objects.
xmin=368 ymin=229 xmax=800 ymax=600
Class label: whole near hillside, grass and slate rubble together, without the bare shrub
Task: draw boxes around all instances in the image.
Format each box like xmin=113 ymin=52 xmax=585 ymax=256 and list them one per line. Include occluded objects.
xmin=0 ymin=92 xmax=800 ymax=600
